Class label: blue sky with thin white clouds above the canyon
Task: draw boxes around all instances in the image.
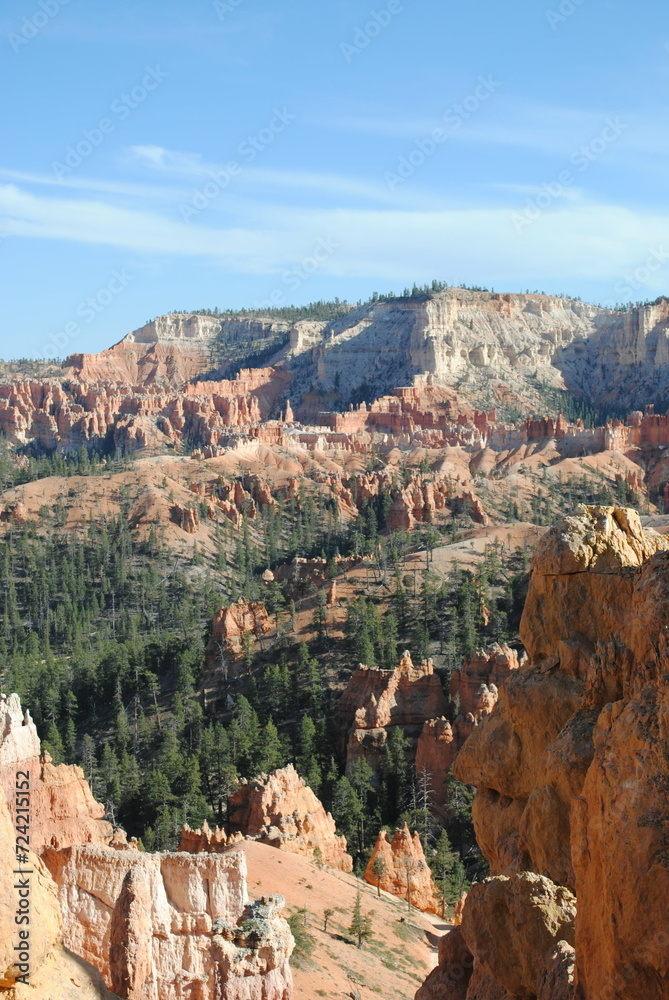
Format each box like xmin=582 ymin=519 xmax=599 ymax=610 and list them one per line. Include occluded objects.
xmin=0 ymin=0 xmax=669 ymax=358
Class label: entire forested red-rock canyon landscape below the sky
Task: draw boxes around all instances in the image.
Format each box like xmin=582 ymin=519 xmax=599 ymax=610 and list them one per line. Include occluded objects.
xmin=0 ymin=289 xmax=669 ymax=1000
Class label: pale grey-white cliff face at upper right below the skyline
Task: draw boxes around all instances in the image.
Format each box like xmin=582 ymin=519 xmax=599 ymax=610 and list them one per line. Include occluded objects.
xmin=288 ymin=288 xmax=669 ymax=407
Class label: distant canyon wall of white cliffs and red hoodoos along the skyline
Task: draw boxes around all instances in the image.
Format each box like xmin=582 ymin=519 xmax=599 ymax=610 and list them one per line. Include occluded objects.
xmin=0 ymin=289 xmax=669 ymax=457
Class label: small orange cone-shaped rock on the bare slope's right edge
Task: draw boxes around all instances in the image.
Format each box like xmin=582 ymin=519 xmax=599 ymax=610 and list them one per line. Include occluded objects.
xmin=365 ymin=823 xmax=441 ymax=913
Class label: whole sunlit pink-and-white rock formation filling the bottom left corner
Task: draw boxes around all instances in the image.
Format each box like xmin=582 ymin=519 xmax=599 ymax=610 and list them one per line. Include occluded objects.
xmin=0 ymin=695 xmax=294 ymax=1000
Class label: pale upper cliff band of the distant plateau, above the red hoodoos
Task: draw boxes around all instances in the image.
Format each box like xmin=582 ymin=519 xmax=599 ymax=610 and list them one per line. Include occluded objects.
xmin=60 ymin=288 xmax=669 ymax=416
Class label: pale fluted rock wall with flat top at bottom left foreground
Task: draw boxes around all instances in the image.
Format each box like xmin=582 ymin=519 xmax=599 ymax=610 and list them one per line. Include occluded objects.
xmin=45 ymin=844 xmax=293 ymax=1000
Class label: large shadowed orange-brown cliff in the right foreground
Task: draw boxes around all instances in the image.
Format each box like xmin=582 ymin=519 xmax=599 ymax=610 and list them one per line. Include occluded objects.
xmin=420 ymin=507 xmax=669 ymax=1000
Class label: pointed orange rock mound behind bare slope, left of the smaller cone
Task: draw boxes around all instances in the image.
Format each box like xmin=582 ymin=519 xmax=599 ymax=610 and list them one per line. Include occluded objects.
xmin=228 ymin=764 xmax=353 ymax=872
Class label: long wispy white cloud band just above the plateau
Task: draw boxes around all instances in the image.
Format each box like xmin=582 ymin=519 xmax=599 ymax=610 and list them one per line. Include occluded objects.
xmin=0 ymin=185 xmax=669 ymax=300
